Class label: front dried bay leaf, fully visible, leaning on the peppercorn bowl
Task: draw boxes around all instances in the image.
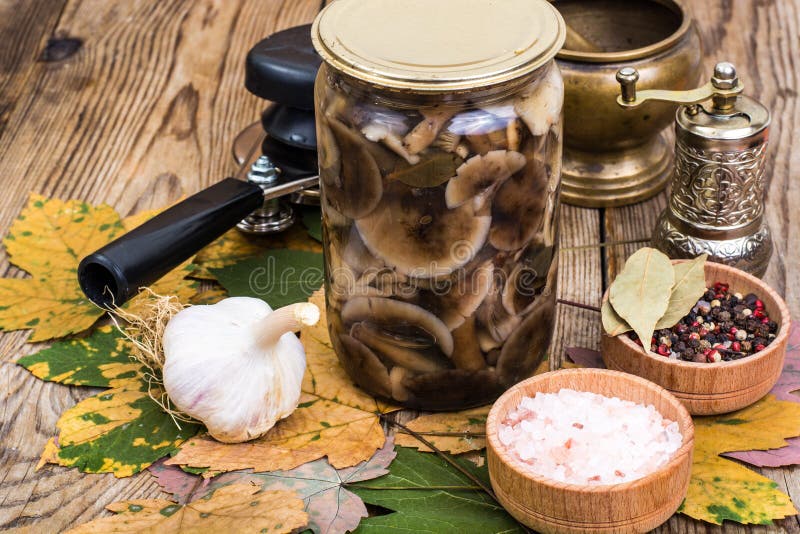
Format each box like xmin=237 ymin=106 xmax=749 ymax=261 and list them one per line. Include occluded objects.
xmin=609 ymin=247 xmax=675 ymax=351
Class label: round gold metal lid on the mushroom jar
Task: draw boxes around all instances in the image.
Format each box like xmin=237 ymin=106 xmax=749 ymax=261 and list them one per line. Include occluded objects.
xmin=311 ymin=0 xmax=566 ymax=93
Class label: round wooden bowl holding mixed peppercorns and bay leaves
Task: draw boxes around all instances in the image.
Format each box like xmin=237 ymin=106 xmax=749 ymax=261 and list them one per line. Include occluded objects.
xmin=602 ymin=260 xmax=791 ymax=415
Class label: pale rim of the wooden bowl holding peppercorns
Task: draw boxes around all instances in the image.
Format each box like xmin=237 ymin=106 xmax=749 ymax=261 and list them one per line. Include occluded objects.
xmin=601 ymin=260 xmax=792 ymax=373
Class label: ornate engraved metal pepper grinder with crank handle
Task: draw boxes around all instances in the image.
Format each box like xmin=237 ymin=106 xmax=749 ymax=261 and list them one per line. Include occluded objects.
xmin=617 ymin=62 xmax=772 ymax=277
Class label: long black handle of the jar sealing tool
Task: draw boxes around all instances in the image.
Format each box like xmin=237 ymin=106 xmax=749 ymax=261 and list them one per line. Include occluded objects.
xmin=78 ymin=178 xmax=264 ymax=308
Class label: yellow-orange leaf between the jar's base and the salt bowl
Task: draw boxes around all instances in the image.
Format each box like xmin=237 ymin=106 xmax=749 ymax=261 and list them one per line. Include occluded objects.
xmin=395 ymin=357 xmax=556 ymax=454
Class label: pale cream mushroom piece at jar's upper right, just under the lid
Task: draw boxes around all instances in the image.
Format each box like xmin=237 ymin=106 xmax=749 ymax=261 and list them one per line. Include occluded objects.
xmin=514 ymin=64 xmax=564 ymax=136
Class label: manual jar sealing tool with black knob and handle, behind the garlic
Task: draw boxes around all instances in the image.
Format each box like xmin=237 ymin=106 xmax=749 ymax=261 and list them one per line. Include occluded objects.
xmin=78 ymin=25 xmax=322 ymax=307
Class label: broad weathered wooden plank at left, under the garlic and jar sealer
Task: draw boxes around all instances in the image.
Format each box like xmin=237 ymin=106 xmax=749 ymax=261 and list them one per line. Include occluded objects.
xmin=0 ymin=0 xmax=320 ymax=532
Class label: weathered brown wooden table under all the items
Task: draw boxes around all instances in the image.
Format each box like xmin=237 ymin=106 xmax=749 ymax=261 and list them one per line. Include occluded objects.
xmin=0 ymin=0 xmax=800 ymax=532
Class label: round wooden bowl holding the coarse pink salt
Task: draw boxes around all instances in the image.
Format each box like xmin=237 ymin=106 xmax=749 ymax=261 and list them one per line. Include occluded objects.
xmin=486 ymin=369 xmax=694 ymax=533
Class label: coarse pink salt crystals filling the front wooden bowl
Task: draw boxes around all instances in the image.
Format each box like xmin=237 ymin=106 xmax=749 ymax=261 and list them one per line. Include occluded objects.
xmin=498 ymin=389 xmax=683 ymax=485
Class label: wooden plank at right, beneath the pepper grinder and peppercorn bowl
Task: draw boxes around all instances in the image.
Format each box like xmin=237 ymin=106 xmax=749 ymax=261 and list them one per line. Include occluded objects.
xmin=604 ymin=0 xmax=800 ymax=533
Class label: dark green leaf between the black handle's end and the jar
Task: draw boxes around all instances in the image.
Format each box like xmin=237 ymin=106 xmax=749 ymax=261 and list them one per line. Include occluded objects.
xmin=210 ymin=249 xmax=323 ymax=308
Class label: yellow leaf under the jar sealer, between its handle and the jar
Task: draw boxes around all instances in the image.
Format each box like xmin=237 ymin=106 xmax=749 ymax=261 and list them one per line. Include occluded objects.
xmin=192 ymin=225 xmax=322 ymax=280
